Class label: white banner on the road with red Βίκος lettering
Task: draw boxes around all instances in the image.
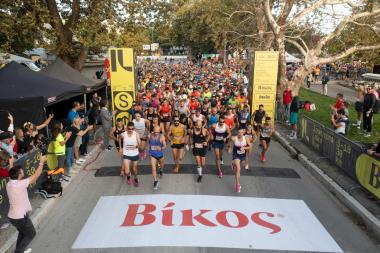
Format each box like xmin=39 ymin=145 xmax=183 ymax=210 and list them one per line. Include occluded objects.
xmin=73 ymin=195 xmax=342 ymax=252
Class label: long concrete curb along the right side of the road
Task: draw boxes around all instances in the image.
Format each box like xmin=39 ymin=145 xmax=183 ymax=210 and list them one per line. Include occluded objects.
xmin=275 ymin=131 xmax=380 ymax=240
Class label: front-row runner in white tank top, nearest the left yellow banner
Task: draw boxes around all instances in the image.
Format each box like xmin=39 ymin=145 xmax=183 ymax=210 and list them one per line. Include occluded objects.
xmin=119 ymin=122 xmax=141 ymax=187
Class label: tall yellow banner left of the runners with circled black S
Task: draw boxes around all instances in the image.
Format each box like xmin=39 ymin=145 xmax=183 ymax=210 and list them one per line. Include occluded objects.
xmin=108 ymin=48 xmax=136 ymax=123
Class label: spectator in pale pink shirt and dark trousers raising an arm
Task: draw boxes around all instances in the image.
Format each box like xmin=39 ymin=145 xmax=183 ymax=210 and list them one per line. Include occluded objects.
xmin=6 ymin=156 xmax=46 ymax=253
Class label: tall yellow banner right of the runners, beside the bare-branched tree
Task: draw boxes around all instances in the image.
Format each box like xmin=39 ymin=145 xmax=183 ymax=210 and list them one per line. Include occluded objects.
xmin=251 ymin=51 xmax=279 ymax=122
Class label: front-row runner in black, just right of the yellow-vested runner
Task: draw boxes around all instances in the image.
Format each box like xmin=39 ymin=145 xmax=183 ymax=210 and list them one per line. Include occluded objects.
xmin=192 ymin=120 xmax=209 ymax=183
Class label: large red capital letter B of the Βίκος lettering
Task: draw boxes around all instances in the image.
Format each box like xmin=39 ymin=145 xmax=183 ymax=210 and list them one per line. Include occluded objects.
xmin=121 ymin=204 xmax=156 ymax=227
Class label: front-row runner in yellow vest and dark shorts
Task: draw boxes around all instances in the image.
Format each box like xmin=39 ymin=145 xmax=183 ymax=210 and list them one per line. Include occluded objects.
xmin=168 ymin=117 xmax=186 ymax=173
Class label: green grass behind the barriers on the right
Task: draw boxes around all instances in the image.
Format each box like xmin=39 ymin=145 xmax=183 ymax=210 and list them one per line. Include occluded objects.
xmin=299 ymin=88 xmax=380 ymax=143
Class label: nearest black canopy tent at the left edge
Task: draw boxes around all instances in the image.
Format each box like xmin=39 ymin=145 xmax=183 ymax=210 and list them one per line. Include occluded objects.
xmin=0 ymin=62 xmax=84 ymax=130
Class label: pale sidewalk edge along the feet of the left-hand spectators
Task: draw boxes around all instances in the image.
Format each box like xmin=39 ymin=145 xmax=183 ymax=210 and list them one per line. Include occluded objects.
xmin=0 ymin=145 xmax=101 ymax=253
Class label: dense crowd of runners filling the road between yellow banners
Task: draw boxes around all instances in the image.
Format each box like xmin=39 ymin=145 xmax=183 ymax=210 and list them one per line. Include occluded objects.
xmin=110 ymin=61 xmax=274 ymax=192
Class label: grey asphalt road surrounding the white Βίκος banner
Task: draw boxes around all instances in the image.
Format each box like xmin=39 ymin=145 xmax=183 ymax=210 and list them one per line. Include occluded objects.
xmin=25 ymin=141 xmax=380 ymax=253
